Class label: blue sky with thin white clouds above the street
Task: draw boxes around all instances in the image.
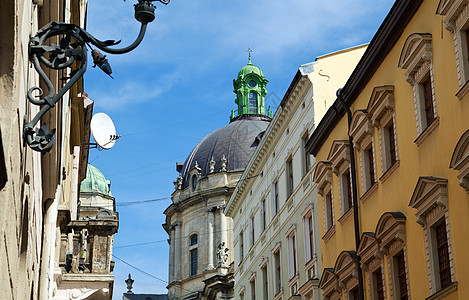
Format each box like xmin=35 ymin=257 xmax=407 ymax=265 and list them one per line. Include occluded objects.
xmin=85 ymin=0 xmax=394 ymax=299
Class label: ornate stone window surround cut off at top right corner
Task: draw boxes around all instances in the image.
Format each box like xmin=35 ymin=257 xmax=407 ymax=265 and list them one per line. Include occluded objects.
xmin=437 ymin=0 xmax=469 ymax=99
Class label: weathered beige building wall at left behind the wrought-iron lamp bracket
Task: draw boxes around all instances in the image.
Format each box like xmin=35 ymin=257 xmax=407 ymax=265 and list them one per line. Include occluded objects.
xmin=0 ymin=0 xmax=89 ymax=299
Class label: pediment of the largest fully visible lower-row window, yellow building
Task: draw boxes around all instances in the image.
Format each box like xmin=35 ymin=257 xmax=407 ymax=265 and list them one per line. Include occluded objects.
xmin=409 ymin=177 xmax=448 ymax=226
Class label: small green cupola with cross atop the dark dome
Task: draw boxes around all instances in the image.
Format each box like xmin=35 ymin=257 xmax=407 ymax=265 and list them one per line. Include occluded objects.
xmin=230 ymin=53 xmax=272 ymax=121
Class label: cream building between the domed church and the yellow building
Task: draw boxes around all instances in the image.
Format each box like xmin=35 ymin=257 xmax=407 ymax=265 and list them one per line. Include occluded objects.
xmin=225 ymin=46 xmax=366 ymax=299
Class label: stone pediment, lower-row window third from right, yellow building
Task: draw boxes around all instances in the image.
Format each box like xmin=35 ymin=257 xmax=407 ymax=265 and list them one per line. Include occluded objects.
xmin=375 ymin=212 xmax=406 ymax=248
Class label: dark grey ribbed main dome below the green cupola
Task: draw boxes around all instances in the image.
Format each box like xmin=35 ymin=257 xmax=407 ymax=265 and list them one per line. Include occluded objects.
xmin=181 ymin=115 xmax=270 ymax=188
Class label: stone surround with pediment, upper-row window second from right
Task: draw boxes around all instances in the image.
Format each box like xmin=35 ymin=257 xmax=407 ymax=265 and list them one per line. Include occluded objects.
xmin=399 ymin=33 xmax=439 ymax=145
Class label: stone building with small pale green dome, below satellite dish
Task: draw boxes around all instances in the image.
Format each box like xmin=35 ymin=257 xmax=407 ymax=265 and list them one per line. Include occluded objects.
xmin=53 ymin=164 xmax=119 ymax=300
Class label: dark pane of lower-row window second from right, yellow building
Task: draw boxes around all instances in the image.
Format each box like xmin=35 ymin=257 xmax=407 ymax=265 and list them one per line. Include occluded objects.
xmin=435 ymin=221 xmax=451 ymax=289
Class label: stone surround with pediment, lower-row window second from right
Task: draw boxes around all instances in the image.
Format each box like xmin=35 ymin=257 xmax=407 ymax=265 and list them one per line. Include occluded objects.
xmin=409 ymin=177 xmax=457 ymax=299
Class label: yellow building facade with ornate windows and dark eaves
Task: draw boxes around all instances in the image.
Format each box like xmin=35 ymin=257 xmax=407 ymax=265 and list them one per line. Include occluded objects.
xmin=306 ymin=0 xmax=469 ymax=299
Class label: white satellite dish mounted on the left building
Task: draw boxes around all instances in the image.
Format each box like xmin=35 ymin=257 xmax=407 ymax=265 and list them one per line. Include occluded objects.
xmin=90 ymin=113 xmax=120 ymax=149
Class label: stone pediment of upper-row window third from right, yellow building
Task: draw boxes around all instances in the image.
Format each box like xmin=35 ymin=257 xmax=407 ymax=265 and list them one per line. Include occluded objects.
xmin=366 ymin=85 xmax=394 ymax=127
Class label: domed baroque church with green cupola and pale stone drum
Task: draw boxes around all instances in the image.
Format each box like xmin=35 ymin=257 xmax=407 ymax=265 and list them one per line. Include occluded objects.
xmin=163 ymin=57 xmax=272 ymax=299
